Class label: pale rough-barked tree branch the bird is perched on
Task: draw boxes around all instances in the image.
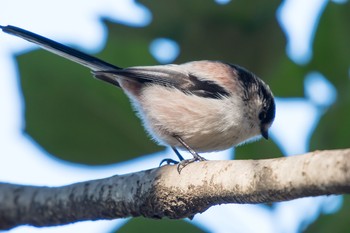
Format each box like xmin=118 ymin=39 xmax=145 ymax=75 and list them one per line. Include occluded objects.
xmin=0 ymin=149 xmax=350 ymax=229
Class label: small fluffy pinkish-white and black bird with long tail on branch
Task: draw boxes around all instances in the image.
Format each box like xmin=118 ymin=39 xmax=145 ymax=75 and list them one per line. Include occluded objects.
xmin=0 ymin=26 xmax=275 ymax=173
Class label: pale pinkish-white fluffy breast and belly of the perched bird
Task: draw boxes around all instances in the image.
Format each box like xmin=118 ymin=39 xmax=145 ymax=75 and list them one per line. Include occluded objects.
xmin=134 ymin=85 xmax=260 ymax=152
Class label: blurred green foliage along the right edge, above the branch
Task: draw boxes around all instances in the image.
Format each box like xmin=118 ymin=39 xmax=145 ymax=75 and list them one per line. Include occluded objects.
xmin=308 ymin=1 xmax=350 ymax=150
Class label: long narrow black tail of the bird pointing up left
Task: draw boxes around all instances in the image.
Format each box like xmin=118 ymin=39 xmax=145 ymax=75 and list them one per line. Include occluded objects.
xmin=0 ymin=25 xmax=121 ymax=72
